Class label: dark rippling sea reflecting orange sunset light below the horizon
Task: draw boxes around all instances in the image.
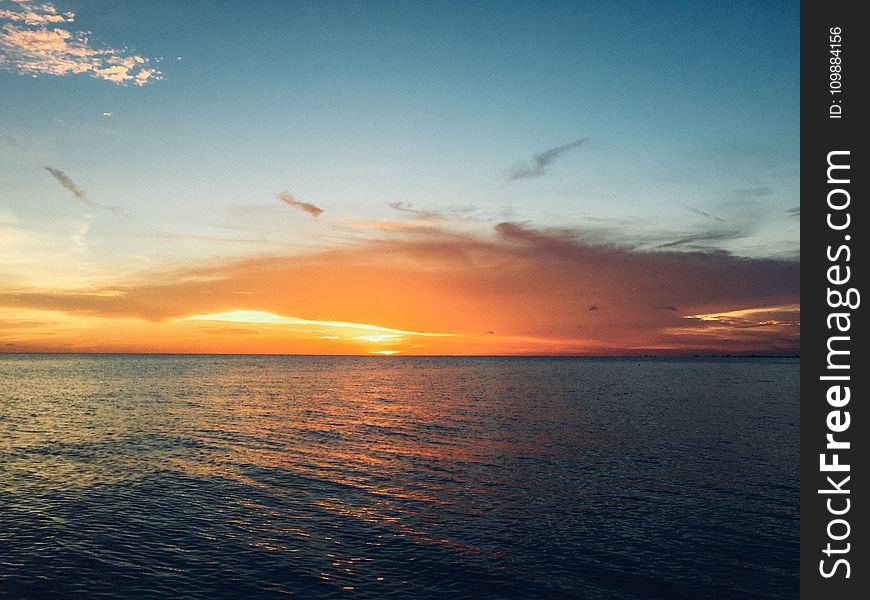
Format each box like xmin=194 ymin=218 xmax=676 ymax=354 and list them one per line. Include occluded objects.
xmin=0 ymin=355 xmax=799 ymax=600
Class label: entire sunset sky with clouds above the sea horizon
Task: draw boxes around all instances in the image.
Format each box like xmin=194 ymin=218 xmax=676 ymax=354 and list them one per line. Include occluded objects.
xmin=0 ymin=0 xmax=800 ymax=355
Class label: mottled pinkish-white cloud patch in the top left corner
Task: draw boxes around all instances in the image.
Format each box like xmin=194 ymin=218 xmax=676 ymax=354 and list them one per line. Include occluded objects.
xmin=0 ymin=0 xmax=162 ymax=86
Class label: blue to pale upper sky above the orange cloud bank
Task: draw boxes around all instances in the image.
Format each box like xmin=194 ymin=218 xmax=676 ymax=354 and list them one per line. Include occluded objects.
xmin=0 ymin=0 xmax=799 ymax=354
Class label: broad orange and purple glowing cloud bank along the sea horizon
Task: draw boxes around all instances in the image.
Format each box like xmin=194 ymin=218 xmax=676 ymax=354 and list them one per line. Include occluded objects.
xmin=0 ymin=223 xmax=800 ymax=355
